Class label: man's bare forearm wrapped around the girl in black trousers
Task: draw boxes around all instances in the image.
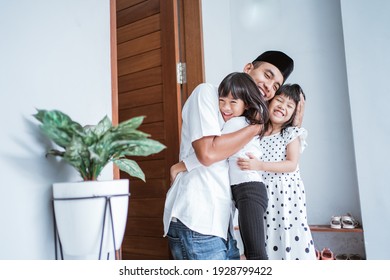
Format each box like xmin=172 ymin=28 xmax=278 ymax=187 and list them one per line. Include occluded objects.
xmin=192 ymin=125 xmax=261 ymax=166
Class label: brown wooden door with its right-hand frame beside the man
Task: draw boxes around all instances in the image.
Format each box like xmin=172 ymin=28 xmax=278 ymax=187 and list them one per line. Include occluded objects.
xmin=114 ymin=0 xmax=204 ymax=259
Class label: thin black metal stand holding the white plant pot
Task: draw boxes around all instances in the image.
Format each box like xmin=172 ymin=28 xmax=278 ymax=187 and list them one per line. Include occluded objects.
xmin=52 ymin=193 xmax=130 ymax=260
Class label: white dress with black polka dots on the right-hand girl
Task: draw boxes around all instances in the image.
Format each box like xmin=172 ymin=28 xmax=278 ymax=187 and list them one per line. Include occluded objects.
xmin=261 ymin=127 xmax=316 ymax=260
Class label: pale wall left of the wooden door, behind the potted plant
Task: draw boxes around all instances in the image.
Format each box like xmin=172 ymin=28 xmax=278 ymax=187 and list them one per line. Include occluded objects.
xmin=0 ymin=0 xmax=112 ymax=259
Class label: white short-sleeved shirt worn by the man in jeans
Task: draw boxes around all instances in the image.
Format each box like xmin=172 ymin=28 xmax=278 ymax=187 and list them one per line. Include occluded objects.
xmin=163 ymin=84 xmax=233 ymax=239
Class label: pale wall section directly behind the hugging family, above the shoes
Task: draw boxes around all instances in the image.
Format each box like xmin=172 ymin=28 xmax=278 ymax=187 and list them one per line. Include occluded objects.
xmin=202 ymin=0 xmax=361 ymax=224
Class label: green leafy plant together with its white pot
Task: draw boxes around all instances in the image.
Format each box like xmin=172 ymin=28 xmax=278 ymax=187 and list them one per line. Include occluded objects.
xmin=34 ymin=109 xmax=165 ymax=259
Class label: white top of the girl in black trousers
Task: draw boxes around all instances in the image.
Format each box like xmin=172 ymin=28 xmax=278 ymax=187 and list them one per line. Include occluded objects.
xmin=222 ymin=117 xmax=263 ymax=185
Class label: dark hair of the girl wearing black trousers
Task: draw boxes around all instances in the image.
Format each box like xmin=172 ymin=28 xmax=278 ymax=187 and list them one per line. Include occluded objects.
xmin=218 ymin=72 xmax=269 ymax=137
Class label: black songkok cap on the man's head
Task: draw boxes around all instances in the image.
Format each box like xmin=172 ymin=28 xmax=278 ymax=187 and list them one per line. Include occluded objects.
xmin=252 ymin=51 xmax=294 ymax=82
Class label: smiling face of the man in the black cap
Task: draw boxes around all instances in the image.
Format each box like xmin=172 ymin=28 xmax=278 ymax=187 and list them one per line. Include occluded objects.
xmin=244 ymin=62 xmax=283 ymax=101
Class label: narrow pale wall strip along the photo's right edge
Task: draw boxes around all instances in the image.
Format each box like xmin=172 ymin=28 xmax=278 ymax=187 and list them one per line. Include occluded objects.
xmin=341 ymin=0 xmax=390 ymax=259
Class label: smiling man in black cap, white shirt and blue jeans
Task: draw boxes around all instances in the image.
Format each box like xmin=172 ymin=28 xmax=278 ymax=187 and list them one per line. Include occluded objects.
xmin=164 ymin=51 xmax=294 ymax=260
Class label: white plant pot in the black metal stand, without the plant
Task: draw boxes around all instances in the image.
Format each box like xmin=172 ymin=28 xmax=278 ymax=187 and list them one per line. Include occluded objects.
xmin=53 ymin=179 xmax=129 ymax=259
